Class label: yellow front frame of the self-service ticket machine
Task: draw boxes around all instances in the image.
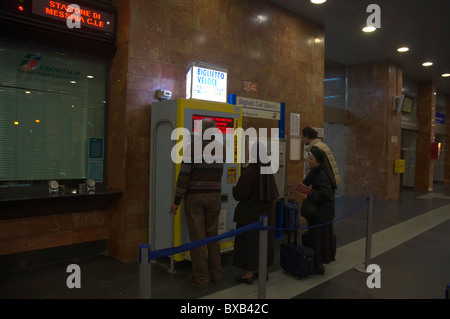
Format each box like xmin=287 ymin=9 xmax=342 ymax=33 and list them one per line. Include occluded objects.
xmin=174 ymin=99 xmax=242 ymax=261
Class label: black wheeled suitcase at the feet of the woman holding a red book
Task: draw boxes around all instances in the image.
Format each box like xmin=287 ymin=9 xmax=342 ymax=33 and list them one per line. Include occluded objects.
xmin=280 ymin=202 xmax=315 ymax=278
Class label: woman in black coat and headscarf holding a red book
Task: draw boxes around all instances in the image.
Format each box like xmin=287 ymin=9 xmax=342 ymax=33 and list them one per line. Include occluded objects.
xmin=302 ymin=147 xmax=337 ymax=274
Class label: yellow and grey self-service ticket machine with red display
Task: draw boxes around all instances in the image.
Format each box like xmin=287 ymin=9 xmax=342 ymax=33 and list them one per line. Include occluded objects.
xmin=149 ymin=99 xmax=242 ymax=261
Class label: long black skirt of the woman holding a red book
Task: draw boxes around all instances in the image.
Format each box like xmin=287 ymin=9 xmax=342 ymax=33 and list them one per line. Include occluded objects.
xmin=303 ymin=224 xmax=336 ymax=265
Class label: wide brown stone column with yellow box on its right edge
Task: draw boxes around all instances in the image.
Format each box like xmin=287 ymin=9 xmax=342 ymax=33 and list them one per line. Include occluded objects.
xmin=345 ymin=61 xmax=402 ymax=199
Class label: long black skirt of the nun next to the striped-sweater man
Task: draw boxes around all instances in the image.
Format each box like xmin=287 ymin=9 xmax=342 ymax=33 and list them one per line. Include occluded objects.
xmin=233 ymin=224 xmax=274 ymax=271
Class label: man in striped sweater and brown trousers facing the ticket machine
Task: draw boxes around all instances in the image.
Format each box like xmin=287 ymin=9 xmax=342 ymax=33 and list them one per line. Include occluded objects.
xmin=169 ymin=118 xmax=224 ymax=288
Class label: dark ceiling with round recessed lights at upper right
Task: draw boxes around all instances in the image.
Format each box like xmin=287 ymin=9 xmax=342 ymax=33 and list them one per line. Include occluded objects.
xmin=271 ymin=0 xmax=450 ymax=98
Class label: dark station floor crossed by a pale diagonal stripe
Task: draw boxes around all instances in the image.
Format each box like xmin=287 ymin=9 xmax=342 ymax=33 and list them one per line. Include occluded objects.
xmin=0 ymin=184 xmax=450 ymax=299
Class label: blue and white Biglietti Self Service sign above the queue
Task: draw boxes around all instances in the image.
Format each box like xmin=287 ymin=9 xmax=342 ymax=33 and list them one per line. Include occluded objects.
xmin=236 ymin=96 xmax=281 ymax=121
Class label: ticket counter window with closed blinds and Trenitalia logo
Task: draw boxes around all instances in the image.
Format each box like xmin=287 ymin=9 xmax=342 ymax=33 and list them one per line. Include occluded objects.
xmin=0 ymin=41 xmax=106 ymax=187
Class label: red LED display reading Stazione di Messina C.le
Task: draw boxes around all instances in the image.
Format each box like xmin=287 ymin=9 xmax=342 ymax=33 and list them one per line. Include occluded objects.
xmin=32 ymin=0 xmax=114 ymax=33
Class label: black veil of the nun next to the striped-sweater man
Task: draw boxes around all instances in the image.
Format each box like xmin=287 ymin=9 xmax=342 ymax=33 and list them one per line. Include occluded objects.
xmin=250 ymin=142 xmax=279 ymax=202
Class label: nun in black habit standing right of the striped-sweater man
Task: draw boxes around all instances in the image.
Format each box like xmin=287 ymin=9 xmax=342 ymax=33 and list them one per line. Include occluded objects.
xmin=232 ymin=142 xmax=279 ymax=284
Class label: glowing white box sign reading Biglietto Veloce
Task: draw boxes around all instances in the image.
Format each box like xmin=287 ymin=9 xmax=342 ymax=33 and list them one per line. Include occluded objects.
xmin=186 ymin=61 xmax=228 ymax=103
